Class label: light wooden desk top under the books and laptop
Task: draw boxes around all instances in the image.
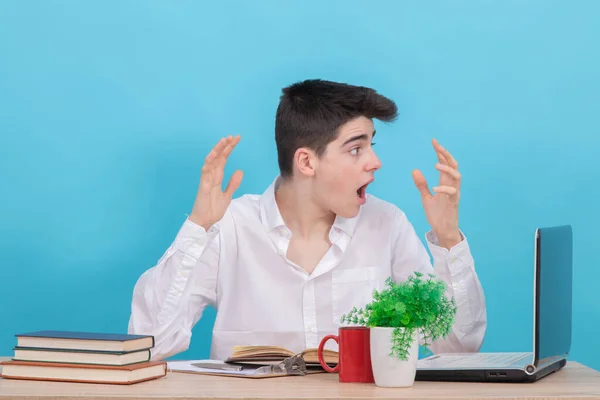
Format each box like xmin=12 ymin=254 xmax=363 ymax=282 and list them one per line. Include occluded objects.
xmin=0 ymin=362 xmax=600 ymax=400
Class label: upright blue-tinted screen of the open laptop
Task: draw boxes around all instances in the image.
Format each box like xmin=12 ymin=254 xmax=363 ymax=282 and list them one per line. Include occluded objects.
xmin=534 ymin=225 xmax=573 ymax=364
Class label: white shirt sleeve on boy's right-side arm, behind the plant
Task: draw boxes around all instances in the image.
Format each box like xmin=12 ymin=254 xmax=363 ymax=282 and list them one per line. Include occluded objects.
xmin=392 ymin=210 xmax=487 ymax=353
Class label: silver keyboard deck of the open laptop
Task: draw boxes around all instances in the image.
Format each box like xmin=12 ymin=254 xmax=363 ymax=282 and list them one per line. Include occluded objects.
xmin=419 ymin=353 xmax=532 ymax=368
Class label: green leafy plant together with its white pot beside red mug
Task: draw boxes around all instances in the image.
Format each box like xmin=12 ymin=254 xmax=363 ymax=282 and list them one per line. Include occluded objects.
xmin=341 ymin=272 xmax=456 ymax=387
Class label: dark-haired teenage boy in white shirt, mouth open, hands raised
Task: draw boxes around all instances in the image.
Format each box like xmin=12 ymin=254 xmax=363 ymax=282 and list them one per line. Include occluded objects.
xmin=129 ymin=80 xmax=486 ymax=360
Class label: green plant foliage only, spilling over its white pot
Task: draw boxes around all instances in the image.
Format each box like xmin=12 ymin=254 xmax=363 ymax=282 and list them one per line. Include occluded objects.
xmin=341 ymin=272 xmax=456 ymax=360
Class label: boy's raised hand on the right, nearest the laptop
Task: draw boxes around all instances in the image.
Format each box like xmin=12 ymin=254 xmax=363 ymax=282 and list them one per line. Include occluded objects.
xmin=412 ymin=139 xmax=462 ymax=249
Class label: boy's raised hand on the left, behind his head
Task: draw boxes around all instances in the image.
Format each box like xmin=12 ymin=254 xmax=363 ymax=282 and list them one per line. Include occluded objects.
xmin=189 ymin=135 xmax=244 ymax=230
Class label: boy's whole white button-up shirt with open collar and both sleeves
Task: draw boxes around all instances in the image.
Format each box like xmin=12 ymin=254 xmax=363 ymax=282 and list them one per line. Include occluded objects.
xmin=129 ymin=180 xmax=486 ymax=360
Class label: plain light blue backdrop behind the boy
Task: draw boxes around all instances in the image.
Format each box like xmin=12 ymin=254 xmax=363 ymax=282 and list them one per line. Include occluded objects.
xmin=0 ymin=0 xmax=600 ymax=368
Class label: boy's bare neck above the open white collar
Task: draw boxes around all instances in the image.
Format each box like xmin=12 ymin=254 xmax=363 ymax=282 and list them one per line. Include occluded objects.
xmin=275 ymin=179 xmax=336 ymax=240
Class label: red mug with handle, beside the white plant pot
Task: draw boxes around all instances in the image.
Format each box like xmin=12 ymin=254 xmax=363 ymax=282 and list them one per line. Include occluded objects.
xmin=317 ymin=326 xmax=375 ymax=383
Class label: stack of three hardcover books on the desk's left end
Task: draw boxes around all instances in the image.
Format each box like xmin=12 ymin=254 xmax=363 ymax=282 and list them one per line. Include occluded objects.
xmin=0 ymin=331 xmax=167 ymax=384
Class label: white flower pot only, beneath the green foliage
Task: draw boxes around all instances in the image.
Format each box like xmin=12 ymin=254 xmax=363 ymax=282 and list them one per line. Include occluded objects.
xmin=370 ymin=327 xmax=419 ymax=387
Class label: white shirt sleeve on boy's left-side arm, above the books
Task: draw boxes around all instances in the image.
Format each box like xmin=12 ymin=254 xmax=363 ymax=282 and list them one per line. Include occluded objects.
xmin=128 ymin=219 xmax=219 ymax=360
